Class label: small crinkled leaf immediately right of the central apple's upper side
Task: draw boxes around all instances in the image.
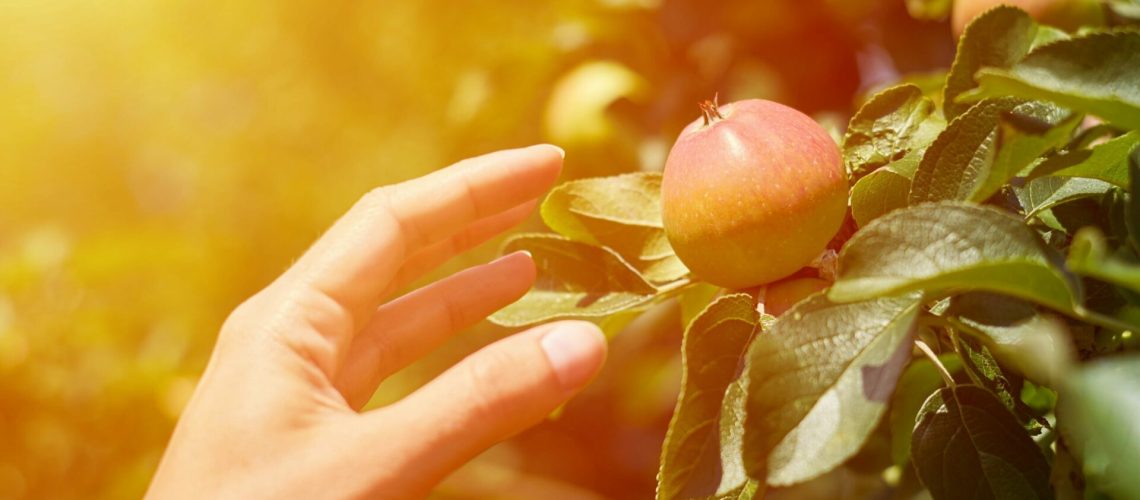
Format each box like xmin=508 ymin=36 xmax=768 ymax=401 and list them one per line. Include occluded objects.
xmin=842 ymin=84 xmax=945 ymax=179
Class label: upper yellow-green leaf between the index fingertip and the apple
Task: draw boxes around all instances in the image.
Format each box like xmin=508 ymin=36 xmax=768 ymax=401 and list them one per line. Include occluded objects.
xmin=542 ymin=173 xmax=689 ymax=282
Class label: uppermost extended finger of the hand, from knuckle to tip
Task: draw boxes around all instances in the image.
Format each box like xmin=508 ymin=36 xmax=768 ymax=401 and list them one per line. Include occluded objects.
xmin=275 ymin=145 xmax=563 ymax=341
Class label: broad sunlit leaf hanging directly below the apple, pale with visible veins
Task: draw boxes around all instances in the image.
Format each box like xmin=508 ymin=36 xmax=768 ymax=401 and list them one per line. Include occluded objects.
xmin=744 ymin=294 xmax=920 ymax=485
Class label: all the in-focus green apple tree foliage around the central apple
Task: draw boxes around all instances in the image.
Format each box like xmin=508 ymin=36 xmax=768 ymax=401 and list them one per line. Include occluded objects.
xmin=494 ymin=7 xmax=1140 ymax=499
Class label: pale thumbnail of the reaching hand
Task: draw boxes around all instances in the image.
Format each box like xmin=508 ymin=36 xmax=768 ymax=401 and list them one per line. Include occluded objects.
xmin=540 ymin=321 xmax=605 ymax=392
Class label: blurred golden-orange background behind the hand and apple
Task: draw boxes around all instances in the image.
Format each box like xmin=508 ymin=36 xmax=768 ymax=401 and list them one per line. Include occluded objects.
xmin=0 ymin=0 xmax=953 ymax=499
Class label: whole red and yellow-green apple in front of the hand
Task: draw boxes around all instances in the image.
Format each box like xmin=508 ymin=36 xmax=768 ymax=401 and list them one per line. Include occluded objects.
xmin=661 ymin=99 xmax=848 ymax=289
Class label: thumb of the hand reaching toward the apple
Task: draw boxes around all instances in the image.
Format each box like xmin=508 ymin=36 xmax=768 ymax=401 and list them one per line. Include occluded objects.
xmin=362 ymin=321 xmax=606 ymax=487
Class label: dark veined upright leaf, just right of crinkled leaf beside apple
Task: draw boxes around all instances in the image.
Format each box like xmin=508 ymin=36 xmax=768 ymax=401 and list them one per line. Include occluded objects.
xmin=910 ymin=99 xmax=1023 ymax=205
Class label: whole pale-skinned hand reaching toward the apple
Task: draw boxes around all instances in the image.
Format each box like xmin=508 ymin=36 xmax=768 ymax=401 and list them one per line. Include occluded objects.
xmin=147 ymin=146 xmax=605 ymax=499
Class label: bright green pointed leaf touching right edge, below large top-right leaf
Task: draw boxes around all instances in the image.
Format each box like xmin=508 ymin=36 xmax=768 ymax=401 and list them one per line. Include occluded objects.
xmin=1029 ymin=131 xmax=1140 ymax=189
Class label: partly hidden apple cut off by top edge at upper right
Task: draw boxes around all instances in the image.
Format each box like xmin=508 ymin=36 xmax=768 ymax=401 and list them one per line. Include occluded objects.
xmin=951 ymin=0 xmax=1105 ymax=38
